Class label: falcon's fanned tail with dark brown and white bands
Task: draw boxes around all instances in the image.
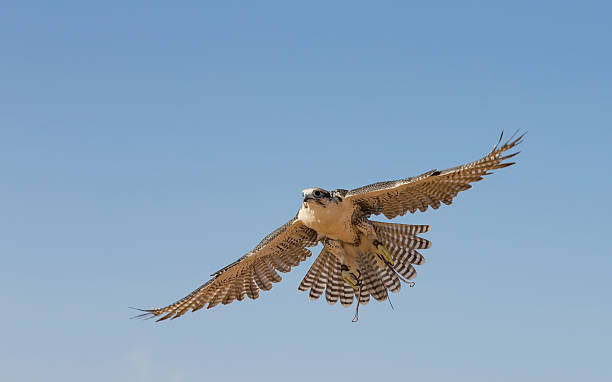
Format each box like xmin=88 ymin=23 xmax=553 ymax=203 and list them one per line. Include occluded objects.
xmin=298 ymin=221 xmax=431 ymax=314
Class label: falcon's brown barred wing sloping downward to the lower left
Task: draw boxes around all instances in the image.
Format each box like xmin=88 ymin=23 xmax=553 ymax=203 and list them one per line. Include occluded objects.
xmin=137 ymin=217 xmax=317 ymax=321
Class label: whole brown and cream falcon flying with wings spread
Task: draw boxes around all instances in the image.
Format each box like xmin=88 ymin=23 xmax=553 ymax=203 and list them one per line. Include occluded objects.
xmin=136 ymin=133 xmax=525 ymax=321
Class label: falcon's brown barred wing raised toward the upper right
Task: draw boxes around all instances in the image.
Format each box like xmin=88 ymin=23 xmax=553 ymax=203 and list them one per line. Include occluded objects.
xmin=344 ymin=133 xmax=525 ymax=219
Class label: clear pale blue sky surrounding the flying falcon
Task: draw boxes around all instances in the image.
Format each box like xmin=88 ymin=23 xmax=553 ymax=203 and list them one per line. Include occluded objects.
xmin=0 ymin=1 xmax=612 ymax=382
